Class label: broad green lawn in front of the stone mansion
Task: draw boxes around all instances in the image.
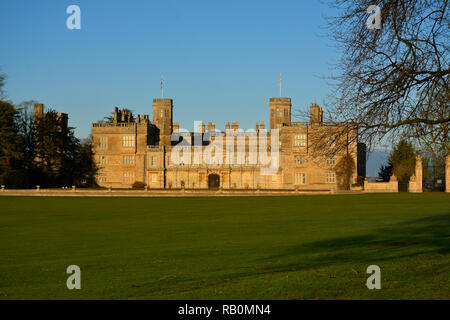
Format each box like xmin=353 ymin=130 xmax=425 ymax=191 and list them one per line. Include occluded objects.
xmin=0 ymin=193 xmax=450 ymax=299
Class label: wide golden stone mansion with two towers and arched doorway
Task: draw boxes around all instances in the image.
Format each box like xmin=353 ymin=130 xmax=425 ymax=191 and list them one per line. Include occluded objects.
xmin=92 ymin=98 xmax=365 ymax=190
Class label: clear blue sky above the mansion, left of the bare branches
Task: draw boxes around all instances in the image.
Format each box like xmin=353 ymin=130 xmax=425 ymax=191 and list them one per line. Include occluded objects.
xmin=0 ymin=0 xmax=337 ymax=138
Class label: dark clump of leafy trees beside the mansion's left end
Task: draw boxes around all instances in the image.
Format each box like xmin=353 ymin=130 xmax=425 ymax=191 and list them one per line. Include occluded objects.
xmin=0 ymin=70 xmax=97 ymax=188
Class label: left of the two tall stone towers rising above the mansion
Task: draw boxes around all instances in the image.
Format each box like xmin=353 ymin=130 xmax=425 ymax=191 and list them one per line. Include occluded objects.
xmin=153 ymin=99 xmax=173 ymax=145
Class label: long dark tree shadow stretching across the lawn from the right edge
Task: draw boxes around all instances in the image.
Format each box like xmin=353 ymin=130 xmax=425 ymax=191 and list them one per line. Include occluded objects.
xmin=131 ymin=213 xmax=450 ymax=294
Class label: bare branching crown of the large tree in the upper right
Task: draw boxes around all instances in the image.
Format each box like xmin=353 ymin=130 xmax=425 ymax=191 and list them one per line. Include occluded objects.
xmin=325 ymin=0 xmax=450 ymax=150
